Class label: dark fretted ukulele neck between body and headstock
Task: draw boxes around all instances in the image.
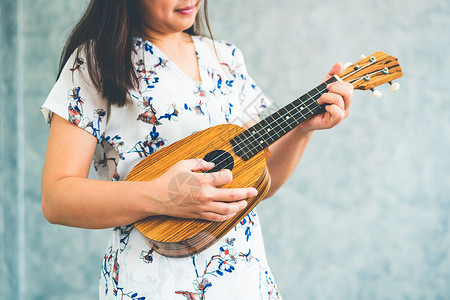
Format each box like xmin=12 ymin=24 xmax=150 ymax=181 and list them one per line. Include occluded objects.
xmin=230 ymin=77 xmax=337 ymax=160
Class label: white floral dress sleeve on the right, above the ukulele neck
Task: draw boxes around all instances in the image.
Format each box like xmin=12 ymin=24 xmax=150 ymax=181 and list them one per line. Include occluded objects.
xmin=233 ymin=48 xmax=272 ymax=125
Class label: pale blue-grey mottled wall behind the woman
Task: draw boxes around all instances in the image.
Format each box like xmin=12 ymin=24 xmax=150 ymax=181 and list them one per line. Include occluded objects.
xmin=0 ymin=0 xmax=450 ymax=300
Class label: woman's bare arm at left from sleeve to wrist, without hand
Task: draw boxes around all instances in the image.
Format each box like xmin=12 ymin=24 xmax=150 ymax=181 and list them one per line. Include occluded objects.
xmin=41 ymin=114 xmax=161 ymax=228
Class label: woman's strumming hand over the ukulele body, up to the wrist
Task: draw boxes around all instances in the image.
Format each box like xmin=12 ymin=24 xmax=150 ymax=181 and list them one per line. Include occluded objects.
xmin=149 ymin=159 xmax=258 ymax=221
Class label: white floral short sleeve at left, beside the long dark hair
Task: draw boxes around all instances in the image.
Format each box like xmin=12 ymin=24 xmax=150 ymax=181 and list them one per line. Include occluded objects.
xmin=41 ymin=51 xmax=107 ymax=142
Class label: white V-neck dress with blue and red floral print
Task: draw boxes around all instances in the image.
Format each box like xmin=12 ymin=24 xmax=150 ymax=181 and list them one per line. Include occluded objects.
xmin=42 ymin=36 xmax=281 ymax=300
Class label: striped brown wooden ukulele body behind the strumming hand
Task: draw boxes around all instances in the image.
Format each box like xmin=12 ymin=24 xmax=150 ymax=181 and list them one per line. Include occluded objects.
xmin=126 ymin=124 xmax=270 ymax=257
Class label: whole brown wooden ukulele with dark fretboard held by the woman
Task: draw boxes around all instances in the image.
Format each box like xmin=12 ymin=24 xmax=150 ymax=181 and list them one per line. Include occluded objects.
xmin=126 ymin=51 xmax=403 ymax=257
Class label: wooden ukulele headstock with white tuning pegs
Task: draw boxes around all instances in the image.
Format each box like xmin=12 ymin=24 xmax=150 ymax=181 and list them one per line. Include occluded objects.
xmin=337 ymin=51 xmax=403 ymax=97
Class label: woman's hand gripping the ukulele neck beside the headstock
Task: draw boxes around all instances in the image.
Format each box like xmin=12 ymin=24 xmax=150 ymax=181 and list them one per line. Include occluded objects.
xmin=296 ymin=63 xmax=353 ymax=134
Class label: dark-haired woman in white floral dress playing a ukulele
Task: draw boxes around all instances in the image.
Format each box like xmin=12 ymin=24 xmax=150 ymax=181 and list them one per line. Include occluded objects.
xmin=42 ymin=0 xmax=353 ymax=299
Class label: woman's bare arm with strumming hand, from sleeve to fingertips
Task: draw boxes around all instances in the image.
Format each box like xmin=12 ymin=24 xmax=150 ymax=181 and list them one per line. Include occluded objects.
xmin=41 ymin=114 xmax=256 ymax=228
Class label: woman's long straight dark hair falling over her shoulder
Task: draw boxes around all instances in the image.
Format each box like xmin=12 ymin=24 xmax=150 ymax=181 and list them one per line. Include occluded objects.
xmin=57 ymin=0 xmax=212 ymax=106
